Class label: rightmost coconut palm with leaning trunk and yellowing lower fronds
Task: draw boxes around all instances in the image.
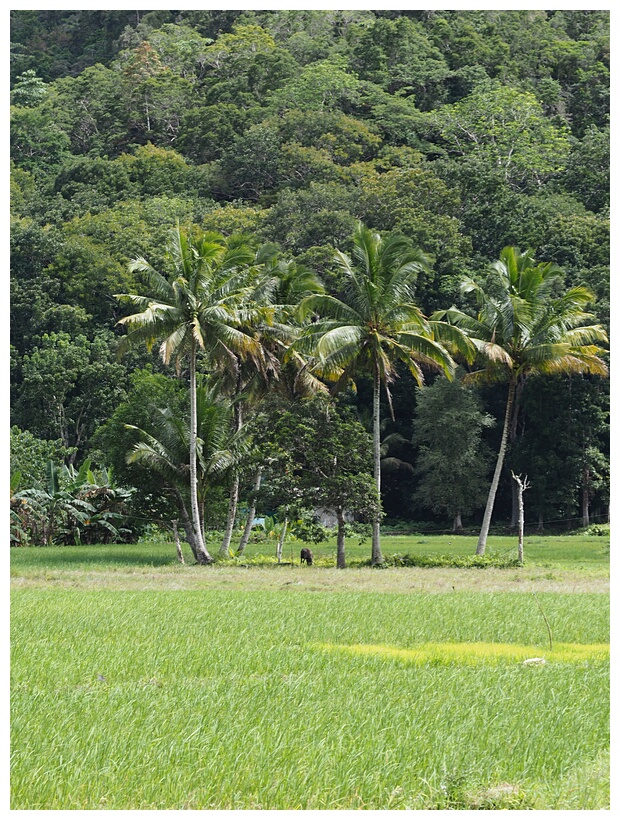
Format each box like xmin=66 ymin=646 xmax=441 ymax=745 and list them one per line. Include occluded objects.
xmin=431 ymin=242 xmax=607 ymax=555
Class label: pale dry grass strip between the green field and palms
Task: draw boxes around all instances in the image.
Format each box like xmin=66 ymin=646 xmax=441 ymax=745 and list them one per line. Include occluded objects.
xmin=11 ymin=565 xmax=609 ymax=594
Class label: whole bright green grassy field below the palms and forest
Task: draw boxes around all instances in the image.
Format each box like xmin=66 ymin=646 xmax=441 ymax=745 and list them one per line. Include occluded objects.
xmin=11 ymin=537 xmax=609 ymax=810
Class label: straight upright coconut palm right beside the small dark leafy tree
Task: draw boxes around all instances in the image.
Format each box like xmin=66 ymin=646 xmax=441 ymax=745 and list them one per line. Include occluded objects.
xmin=293 ymin=223 xmax=470 ymax=564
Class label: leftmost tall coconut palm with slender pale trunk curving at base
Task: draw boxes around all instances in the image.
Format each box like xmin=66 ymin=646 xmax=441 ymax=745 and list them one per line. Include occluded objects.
xmin=117 ymin=224 xmax=257 ymax=563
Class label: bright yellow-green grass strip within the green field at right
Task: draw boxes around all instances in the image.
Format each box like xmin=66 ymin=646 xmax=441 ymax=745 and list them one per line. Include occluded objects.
xmin=315 ymin=641 xmax=609 ymax=665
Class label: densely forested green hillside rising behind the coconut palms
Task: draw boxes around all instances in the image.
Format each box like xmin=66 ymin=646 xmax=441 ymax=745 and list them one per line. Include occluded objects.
xmin=11 ymin=10 xmax=609 ymax=538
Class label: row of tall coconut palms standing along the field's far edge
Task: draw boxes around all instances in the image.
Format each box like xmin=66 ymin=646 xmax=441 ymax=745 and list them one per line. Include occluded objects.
xmin=119 ymin=224 xmax=607 ymax=564
